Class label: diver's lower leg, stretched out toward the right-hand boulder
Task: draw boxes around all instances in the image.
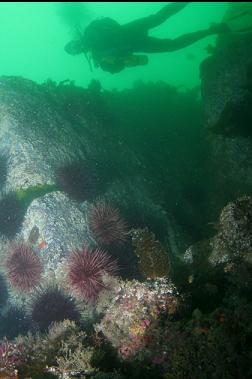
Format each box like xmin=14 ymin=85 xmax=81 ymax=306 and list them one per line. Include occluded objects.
xmin=135 ymin=24 xmax=229 ymax=53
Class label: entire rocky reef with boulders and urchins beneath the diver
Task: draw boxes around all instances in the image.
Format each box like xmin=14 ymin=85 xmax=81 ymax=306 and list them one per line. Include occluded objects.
xmin=0 ymin=34 xmax=252 ymax=379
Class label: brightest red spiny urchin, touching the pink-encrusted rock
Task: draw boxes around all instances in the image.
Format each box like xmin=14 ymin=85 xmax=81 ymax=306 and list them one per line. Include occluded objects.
xmin=68 ymin=246 xmax=117 ymax=302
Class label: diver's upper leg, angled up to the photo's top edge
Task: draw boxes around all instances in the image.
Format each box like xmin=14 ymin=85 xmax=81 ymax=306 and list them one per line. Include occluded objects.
xmin=123 ymin=2 xmax=189 ymax=32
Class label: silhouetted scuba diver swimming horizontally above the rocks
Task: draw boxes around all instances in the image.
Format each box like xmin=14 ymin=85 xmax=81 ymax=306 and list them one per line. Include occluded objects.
xmin=65 ymin=2 xmax=229 ymax=74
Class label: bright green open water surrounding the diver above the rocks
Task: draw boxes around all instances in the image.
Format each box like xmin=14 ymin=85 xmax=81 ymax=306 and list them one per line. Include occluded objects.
xmin=0 ymin=2 xmax=227 ymax=88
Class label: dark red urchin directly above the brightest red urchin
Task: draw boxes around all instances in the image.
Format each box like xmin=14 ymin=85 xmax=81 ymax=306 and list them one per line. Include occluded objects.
xmin=89 ymin=202 xmax=128 ymax=246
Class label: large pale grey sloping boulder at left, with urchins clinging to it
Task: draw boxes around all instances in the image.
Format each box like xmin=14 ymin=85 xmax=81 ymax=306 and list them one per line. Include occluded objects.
xmin=0 ymin=77 xmax=181 ymax=282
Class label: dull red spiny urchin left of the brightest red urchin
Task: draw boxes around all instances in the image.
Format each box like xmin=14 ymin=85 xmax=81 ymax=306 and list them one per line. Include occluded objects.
xmin=6 ymin=243 xmax=43 ymax=291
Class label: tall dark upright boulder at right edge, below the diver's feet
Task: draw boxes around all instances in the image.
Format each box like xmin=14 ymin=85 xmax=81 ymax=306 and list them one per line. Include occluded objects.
xmin=201 ymin=33 xmax=252 ymax=220
